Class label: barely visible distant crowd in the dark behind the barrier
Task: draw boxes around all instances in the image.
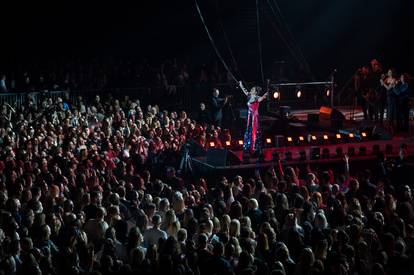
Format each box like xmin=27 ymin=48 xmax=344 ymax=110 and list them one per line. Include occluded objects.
xmin=0 ymin=57 xmax=233 ymax=93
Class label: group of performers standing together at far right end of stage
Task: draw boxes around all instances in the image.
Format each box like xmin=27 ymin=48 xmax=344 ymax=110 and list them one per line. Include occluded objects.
xmin=354 ymin=59 xmax=411 ymax=132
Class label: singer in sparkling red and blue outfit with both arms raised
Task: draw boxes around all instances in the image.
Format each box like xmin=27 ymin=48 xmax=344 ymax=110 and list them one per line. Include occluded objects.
xmin=239 ymin=81 xmax=268 ymax=153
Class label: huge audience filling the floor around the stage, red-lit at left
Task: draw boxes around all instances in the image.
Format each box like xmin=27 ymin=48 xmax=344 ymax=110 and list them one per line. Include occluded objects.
xmin=0 ymin=89 xmax=414 ymax=275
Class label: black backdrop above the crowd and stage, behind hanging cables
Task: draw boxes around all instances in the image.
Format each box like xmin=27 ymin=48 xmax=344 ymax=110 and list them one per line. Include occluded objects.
xmin=0 ymin=0 xmax=414 ymax=83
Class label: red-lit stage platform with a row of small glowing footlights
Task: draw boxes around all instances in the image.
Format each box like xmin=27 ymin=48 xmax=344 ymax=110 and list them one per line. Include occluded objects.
xmin=191 ymin=106 xmax=414 ymax=178
